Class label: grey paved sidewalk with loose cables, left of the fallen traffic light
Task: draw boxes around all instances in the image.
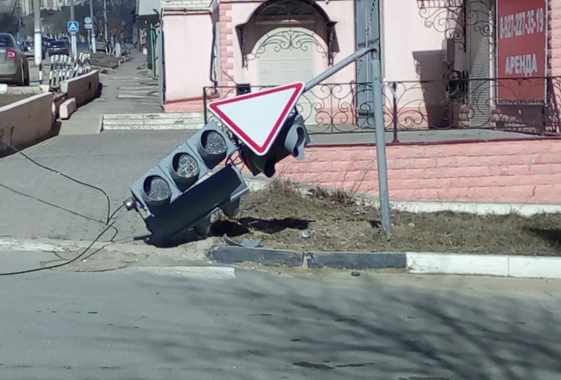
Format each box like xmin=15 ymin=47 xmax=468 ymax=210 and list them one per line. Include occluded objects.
xmin=0 ymin=131 xmax=194 ymax=244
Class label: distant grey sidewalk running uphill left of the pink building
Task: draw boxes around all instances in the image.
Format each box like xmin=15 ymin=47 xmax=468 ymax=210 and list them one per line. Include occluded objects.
xmin=60 ymin=52 xmax=163 ymax=135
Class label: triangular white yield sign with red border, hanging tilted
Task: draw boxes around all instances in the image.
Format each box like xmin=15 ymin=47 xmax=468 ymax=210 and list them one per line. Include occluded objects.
xmin=208 ymin=82 xmax=304 ymax=156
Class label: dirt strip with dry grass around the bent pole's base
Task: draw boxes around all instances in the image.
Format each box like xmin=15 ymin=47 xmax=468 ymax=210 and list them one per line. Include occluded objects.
xmin=209 ymin=181 xmax=561 ymax=256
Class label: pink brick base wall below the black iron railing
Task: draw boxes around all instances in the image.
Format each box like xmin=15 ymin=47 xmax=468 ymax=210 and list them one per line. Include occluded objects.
xmin=277 ymin=138 xmax=561 ymax=203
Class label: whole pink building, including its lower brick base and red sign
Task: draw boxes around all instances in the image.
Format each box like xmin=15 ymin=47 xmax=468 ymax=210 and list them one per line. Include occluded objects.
xmin=140 ymin=0 xmax=561 ymax=204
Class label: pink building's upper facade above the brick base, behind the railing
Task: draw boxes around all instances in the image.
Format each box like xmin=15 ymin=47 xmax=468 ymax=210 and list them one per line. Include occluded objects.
xmin=155 ymin=0 xmax=561 ymax=134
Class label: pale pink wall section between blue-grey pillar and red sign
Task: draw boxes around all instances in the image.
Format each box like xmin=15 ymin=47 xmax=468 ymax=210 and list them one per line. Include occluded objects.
xmin=381 ymin=0 xmax=466 ymax=128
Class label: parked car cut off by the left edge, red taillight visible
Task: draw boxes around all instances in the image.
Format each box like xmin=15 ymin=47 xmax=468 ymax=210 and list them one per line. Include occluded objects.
xmin=0 ymin=33 xmax=29 ymax=86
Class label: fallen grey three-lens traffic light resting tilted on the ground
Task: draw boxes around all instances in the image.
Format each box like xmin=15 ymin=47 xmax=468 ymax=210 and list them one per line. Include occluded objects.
xmin=127 ymin=121 xmax=248 ymax=245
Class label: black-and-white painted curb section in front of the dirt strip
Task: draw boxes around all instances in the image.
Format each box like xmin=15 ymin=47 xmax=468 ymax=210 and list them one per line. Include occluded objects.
xmin=207 ymin=246 xmax=561 ymax=279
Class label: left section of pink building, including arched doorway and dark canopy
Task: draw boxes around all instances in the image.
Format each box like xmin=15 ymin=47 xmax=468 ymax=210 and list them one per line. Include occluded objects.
xmin=162 ymin=0 xmax=356 ymax=111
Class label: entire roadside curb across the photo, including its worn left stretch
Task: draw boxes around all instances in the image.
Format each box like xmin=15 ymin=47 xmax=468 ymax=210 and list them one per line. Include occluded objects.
xmin=0 ymin=238 xmax=561 ymax=279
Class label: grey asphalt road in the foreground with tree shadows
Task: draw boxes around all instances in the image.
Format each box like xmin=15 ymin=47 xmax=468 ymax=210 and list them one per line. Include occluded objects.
xmin=0 ymin=252 xmax=561 ymax=380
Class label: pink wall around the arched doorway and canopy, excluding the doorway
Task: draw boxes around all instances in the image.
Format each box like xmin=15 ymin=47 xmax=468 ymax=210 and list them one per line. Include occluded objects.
xmin=162 ymin=0 xmax=356 ymax=111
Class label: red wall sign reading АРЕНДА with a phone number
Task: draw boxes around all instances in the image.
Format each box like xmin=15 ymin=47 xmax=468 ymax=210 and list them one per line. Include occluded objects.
xmin=497 ymin=0 xmax=547 ymax=102
